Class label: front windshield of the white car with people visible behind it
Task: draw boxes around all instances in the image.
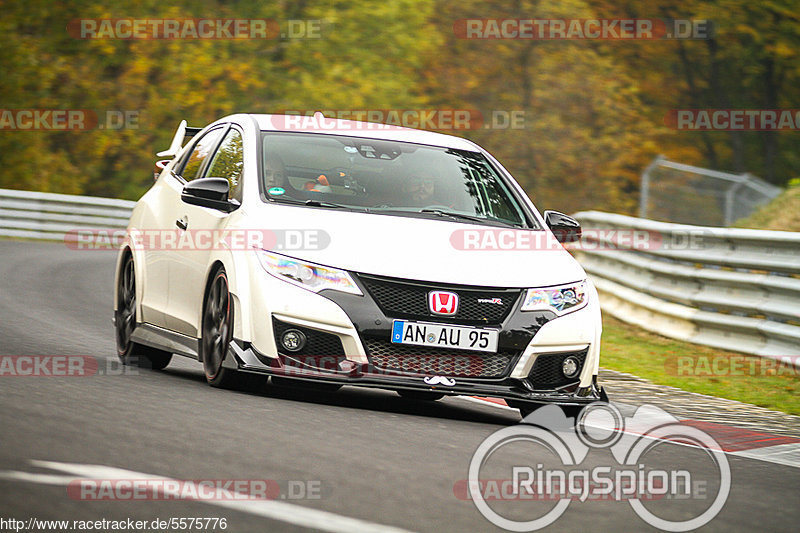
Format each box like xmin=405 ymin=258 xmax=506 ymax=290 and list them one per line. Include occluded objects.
xmin=261 ymin=132 xmax=534 ymax=227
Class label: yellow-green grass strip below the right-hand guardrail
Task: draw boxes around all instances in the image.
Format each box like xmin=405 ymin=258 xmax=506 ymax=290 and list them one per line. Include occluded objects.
xmin=600 ymin=316 xmax=800 ymax=415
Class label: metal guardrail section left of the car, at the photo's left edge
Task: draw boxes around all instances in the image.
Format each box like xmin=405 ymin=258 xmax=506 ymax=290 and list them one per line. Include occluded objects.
xmin=0 ymin=189 xmax=135 ymax=241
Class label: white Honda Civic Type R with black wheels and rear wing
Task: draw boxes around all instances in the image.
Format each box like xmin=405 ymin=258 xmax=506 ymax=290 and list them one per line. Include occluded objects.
xmin=114 ymin=114 xmax=607 ymax=415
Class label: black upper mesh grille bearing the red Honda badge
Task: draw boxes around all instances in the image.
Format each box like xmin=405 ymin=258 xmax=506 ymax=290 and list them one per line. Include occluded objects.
xmin=359 ymin=274 xmax=521 ymax=326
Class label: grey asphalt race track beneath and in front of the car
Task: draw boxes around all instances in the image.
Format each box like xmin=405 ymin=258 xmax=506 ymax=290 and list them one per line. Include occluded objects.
xmin=0 ymin=241 xmax=800 ymax=531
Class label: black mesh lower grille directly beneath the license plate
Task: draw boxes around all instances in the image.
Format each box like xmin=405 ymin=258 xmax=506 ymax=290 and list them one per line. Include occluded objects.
xmin=365 ymin=339 xmax=519 ymax=378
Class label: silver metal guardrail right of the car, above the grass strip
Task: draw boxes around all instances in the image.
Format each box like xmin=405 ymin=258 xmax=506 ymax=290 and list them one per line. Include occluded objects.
xmin=573 ymin=211 xmax=800 ymax=361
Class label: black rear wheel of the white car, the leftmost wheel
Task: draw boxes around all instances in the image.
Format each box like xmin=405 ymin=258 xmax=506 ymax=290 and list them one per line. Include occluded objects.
xmin=114 ymin=255 xmax=172 ymax=370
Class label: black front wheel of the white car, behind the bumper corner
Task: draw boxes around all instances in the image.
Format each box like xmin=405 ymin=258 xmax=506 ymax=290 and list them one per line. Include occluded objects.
xmin=200 ymin=267 xmax=264 ymax=390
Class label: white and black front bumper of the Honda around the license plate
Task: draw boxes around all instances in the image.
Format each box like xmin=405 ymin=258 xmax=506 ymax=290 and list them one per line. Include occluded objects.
xmin=233 ymin=270 xmax=605 ymax=406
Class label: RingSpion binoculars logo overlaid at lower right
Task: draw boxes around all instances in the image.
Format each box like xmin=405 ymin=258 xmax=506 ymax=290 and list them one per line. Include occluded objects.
xmin=466 ymin=403 xmax=731 ymax=531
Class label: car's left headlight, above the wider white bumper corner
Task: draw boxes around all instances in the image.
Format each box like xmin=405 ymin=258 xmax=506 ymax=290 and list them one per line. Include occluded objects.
xmin=256 ymin=250 xmax=363 ymax=296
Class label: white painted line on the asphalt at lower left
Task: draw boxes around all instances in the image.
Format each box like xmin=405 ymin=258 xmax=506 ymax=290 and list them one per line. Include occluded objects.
xmin=0 ymin=460 xmax=418 ymax=533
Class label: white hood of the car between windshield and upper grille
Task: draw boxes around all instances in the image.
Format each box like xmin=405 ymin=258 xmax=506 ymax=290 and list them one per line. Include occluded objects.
xmin=244 ymin=203 xmax=586 ymax=287
